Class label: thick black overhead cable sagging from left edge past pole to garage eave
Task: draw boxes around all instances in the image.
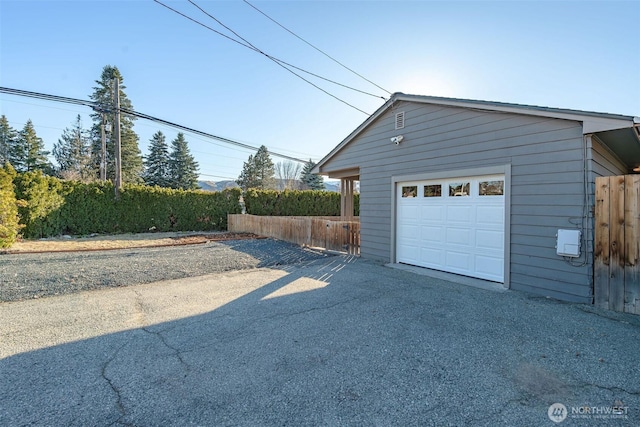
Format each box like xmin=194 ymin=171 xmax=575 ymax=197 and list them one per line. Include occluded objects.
xmin=0 ymin=87 xmax=308 ymax=163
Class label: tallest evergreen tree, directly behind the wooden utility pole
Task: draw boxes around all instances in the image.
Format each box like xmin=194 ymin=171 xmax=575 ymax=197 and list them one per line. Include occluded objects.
xmin=91 ymin=65 xmax=144 ymax=183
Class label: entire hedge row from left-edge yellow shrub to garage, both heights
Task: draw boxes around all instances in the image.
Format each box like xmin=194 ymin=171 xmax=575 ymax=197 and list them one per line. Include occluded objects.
xmin=5 ymin=171 xmax=360 ymax=247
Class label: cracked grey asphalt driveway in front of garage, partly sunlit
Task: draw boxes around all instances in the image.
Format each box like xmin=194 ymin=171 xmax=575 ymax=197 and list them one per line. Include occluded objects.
xmin=0 ymin=252 xmax=640 ymax=426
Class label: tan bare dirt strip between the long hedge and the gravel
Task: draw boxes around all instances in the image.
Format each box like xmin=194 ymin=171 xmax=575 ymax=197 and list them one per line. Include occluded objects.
xmin=3 ymin=232 xmax=263 ymax=254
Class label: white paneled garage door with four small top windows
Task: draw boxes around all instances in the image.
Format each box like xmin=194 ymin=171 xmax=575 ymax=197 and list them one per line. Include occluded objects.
xmin=396 ymin=175 xmax=505 ymax=283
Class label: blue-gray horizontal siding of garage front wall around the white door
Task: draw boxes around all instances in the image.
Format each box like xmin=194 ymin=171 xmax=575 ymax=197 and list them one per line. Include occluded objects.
xmin=323 ymin=103 xmax=591 ymax=302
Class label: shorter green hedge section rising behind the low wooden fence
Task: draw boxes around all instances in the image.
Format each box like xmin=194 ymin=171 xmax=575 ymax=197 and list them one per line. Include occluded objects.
xmin=243 ymin=189 xmax=360 ymax=216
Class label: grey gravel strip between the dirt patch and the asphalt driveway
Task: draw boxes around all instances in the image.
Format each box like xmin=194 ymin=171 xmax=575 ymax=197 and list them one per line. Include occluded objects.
xmin=0 ymin=239 xmax=331 ymax=302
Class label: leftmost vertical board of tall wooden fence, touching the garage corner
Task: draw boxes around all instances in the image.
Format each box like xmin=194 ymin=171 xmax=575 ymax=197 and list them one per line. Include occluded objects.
xmin=593 ymin=177 xmax=610 ymax=309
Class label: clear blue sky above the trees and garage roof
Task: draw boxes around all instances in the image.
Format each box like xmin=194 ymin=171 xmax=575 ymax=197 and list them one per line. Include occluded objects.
xmin=0 ymin=0 xmax=640 ymax=181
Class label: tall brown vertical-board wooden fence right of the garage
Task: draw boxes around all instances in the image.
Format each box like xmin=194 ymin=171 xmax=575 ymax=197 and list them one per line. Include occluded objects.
xmin=593 ymin=175 xmax=640 ymax=314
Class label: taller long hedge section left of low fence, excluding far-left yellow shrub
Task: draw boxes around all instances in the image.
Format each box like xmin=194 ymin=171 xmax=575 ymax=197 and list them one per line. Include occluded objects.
xmin=14 ymin=172 xmax=241 ymax=238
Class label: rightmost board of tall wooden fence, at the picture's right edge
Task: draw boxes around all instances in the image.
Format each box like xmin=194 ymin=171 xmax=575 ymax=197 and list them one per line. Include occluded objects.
xmin=624 ymin=175 xmax=640 ymax=314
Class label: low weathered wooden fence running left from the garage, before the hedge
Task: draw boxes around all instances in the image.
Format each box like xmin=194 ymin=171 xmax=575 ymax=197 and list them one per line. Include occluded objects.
xmin=228 ymin=214 xmax=360 ymax=255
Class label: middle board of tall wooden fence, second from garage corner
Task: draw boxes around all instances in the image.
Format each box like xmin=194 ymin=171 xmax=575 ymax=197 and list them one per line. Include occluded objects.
xmin=609 ymin=176 xmax=625 ymax=311
